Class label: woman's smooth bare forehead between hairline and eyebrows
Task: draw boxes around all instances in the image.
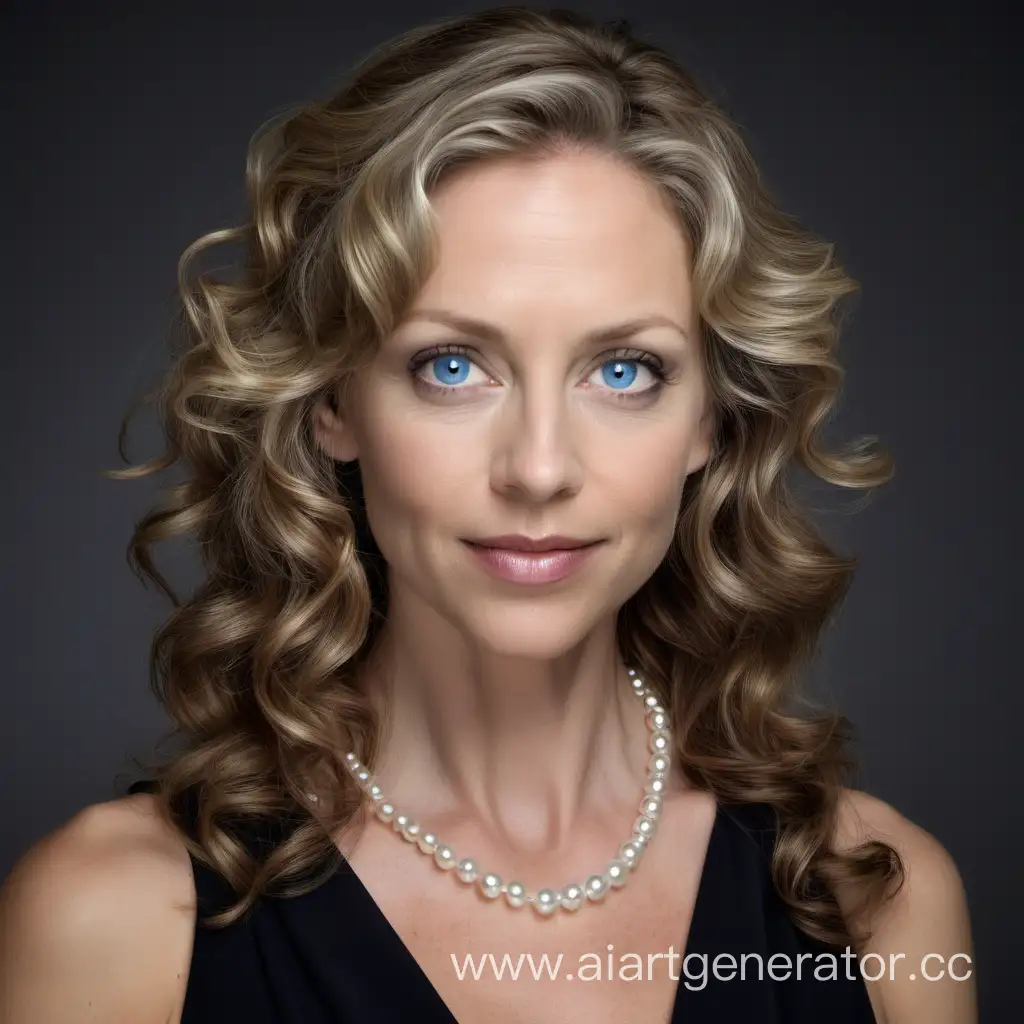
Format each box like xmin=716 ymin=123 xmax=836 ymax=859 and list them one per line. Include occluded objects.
xmin=414 ymin=153 xmax=692 ymax=330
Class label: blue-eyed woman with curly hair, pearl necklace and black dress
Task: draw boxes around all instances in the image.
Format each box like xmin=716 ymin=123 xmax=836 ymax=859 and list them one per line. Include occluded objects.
xmin=2 ymin=8 xmax=975 ymax=1024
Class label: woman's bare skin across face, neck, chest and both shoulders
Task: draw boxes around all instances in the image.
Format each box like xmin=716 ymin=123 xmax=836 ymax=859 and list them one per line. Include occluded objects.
xmin=0 ymin=146 xmax=977 ymax=1024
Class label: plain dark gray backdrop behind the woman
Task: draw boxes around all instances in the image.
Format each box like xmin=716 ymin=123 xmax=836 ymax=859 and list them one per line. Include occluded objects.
xmin=0 ymin=0 xmax=1024 ymax=1020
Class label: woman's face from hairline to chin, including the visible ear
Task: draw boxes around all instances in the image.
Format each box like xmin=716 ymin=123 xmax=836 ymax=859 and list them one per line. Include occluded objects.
xmin=316 ymin=154 xmax=710 ymax=657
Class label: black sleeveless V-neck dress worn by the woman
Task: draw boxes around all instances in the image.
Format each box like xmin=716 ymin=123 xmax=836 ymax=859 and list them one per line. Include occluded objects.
xmin=130 ymin=780 xmax=876 ymax=1024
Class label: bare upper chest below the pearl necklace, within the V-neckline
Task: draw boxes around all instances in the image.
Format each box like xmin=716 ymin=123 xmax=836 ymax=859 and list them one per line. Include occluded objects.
xmin=337 ymin=795 xmax=715 ymax=1024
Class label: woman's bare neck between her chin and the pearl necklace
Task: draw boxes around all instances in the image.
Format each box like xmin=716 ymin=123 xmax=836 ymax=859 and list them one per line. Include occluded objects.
xmin=360 ymin=589 xmax=649 ymax=852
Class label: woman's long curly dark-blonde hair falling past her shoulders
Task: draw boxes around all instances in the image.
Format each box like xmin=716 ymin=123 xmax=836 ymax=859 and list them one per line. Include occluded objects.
xmin=111 ymin=7 xmax=903 ymax=945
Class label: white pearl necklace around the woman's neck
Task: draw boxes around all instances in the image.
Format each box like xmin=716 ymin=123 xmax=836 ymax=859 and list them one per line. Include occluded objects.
xmin=345 ymin=669 xmax=672 ymax=916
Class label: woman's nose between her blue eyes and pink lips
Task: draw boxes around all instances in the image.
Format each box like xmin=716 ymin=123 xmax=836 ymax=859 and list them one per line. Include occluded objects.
xmin=492 ymin=377 xmax=584 ymax=504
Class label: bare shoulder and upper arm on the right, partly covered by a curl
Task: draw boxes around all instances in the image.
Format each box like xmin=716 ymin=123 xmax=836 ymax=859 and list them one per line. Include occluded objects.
xmin=835 ymin=790 xmax=977 ymax=1024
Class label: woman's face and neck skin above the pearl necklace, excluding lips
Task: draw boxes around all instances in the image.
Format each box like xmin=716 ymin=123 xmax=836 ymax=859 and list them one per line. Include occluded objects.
xmin=315 ymin=149 xmax=710 ymax=860
